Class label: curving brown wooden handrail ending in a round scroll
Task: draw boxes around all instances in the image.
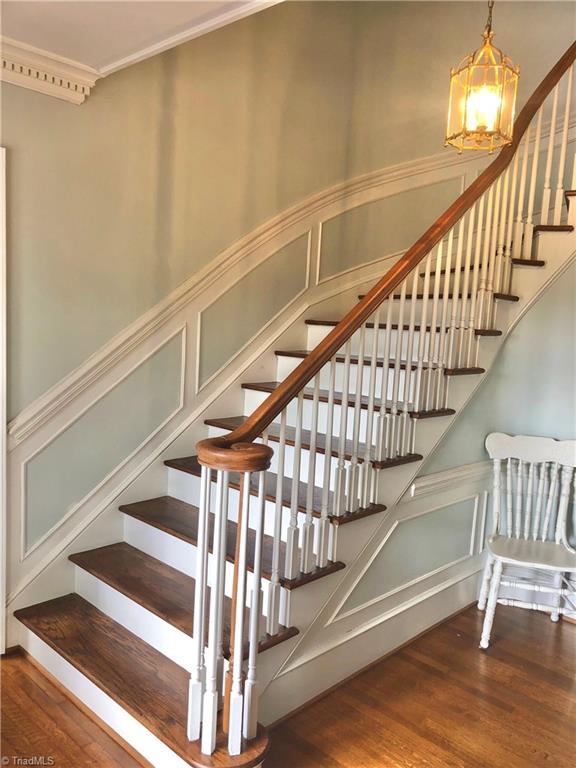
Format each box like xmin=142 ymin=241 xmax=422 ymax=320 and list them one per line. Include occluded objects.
xmin=197 ymin=41 xmax=576 ymax=471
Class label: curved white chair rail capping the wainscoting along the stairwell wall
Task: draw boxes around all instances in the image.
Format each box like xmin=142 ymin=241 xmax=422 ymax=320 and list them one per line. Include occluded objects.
xmin=8 ymin=148 xmax=486 ymax=451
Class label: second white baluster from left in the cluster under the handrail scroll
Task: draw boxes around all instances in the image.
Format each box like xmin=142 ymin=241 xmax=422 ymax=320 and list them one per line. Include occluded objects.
xmin=201 ymin=470 xmax=229 ymax=755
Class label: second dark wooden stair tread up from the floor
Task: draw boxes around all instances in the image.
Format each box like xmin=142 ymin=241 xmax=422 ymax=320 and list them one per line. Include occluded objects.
xmin=68 ymin=542 xmax=298 ymax=656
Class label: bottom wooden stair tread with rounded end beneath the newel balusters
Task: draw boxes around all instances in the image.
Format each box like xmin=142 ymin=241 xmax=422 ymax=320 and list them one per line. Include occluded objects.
xmin=14 ymin=594 xmax=269 ymax=768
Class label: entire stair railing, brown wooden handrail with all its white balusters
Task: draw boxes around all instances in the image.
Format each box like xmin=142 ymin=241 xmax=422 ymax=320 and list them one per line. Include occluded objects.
xmin=188 ymin=43 xmax=576 ymax=755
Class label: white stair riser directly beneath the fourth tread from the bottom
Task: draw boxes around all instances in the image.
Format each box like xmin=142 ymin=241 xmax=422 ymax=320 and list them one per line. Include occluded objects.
xmin=168 ymin=468 xmax=326 ymax=541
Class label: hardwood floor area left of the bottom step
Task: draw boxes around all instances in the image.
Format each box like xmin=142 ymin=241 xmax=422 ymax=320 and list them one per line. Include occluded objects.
xmin=0 ymin=654 xmax=149 ymax=768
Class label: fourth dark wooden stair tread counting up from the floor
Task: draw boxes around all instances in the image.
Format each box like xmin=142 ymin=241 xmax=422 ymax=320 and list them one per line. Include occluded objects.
xmin=164 ymin=456 xmax=386 ymax=525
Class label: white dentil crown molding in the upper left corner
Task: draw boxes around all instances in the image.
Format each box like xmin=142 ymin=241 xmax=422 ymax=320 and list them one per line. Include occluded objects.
xmin=0 ymin=37 xmax=102 ymax=104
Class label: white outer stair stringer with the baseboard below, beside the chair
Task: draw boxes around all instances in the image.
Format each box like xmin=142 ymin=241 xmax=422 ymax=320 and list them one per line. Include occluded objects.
xmin=259 ymin=232 xmax=576 ymax=725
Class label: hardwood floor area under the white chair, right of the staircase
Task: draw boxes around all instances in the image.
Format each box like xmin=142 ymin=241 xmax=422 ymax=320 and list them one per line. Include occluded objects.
xmin=265 ymin=607 xmax=576 ymax=768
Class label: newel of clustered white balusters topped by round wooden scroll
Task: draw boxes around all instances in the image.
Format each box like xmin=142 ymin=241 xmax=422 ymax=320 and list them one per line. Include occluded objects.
xmin=188 ymin=437 xmax=273 ymax=755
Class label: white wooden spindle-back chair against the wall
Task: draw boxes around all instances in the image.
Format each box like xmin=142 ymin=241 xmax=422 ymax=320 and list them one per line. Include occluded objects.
xmin=478 ymin=432 xmax=576 ymax=648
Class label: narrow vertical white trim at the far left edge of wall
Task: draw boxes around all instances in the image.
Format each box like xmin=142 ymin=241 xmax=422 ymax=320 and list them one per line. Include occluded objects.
xmin=0 ymin=147 xmax=8 ymax=653
